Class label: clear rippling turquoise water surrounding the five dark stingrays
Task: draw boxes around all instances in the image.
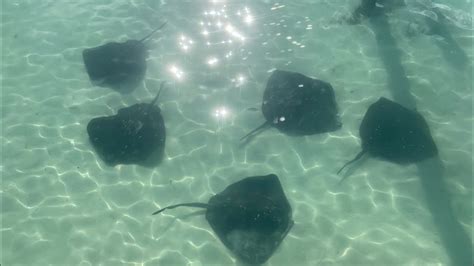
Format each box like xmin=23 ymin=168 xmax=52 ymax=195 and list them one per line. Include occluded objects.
xmin=0 ymin=0 xmax=473 ymax=265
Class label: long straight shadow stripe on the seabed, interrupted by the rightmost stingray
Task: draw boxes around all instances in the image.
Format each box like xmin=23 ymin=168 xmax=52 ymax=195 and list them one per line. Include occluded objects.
xmin=369 ymin=9 xmax=473 ymax=265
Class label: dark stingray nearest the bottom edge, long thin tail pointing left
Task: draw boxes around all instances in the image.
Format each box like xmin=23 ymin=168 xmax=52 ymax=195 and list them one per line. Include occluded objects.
xmin=153 ymin=174 xmax=293 ymax=264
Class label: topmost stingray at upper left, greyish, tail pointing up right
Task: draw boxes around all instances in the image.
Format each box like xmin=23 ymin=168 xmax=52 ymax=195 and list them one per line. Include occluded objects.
xmin=82 ymin=22 xmax=166 ymax=93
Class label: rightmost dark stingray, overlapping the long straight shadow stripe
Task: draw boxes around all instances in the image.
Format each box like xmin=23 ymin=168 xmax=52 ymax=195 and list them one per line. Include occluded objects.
xmin=337 ymin=97 xmax=438 ymax=174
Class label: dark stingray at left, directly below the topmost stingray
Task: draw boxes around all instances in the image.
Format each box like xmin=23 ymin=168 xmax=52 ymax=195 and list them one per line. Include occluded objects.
xmin=87 ymin=83 xmax=166 ymax=167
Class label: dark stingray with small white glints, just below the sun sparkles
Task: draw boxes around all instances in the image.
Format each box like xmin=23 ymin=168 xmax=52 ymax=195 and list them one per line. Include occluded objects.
xmin=241 ymin=70 xmax=342 ymax=140
